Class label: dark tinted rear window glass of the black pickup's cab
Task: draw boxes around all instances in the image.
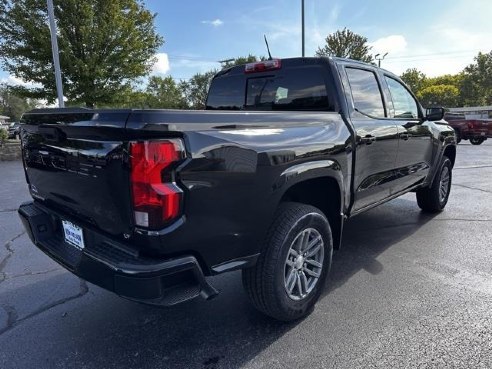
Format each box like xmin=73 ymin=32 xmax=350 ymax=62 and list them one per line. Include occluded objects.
xmin=207 ymin=67 xmax=335 ymax=111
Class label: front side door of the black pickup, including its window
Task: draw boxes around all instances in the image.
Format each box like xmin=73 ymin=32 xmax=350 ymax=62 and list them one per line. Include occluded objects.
xmin=384 ymin=75 xmax=433 ymax=193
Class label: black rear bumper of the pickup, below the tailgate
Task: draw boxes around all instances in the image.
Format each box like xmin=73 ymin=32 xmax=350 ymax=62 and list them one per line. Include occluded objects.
xmin=19 ymin=202 xmax=217 ymax=306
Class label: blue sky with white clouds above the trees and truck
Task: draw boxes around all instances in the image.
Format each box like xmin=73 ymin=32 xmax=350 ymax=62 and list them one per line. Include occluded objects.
xmin=0 ymin=0 xmax=492 ymax=83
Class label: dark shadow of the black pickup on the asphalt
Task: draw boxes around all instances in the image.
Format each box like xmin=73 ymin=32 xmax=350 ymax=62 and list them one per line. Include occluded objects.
xmin=0 ymin=198 xmax=438 ymax=369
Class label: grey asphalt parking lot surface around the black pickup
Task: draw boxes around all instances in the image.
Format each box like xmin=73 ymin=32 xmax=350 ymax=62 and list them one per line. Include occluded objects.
xmin=0 ymin=140 xmax=492 ymax=369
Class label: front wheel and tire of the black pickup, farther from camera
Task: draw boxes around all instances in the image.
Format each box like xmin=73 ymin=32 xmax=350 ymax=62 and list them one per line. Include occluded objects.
xmin=417 ymin=155 xmax=453 ymax=213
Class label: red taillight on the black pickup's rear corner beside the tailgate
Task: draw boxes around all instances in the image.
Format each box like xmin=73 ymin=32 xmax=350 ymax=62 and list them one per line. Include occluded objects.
xmin=130 ymin=139 xmax=185 ymax=229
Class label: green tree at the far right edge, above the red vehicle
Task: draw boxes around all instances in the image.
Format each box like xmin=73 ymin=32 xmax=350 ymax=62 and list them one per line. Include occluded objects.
xmin=461 ymin=51 xmax=492 ymax=106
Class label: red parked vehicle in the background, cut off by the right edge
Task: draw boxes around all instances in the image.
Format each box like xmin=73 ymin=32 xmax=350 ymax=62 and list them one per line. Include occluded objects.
xmin=444 ymin=113 xmax=492 ymax=145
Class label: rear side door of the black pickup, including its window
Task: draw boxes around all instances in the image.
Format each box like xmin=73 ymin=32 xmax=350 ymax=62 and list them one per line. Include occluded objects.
xmin=342 ymin=65 xmax=398 ymax=212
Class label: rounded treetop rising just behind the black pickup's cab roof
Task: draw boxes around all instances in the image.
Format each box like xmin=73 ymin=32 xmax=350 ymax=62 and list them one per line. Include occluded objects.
xmin=316 ymin=28 xmax=374 ymax=63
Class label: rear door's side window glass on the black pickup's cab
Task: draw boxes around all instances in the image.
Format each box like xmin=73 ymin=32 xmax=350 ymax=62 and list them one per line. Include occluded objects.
xmin=345 ymin=68 xmax=385 ymax=118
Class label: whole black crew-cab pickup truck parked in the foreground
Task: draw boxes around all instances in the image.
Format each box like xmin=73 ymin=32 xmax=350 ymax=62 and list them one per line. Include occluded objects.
xmin=19 ymin=58 xmax=456 ymax=321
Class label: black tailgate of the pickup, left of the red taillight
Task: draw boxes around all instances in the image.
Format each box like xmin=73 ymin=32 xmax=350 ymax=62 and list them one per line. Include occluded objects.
xmin=22 ymin=109 xmax=132 ymax=236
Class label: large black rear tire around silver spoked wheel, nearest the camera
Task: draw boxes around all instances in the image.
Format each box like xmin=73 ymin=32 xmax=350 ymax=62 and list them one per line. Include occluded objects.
xmin=242 ymin=202 xmax=333 ymax=321
